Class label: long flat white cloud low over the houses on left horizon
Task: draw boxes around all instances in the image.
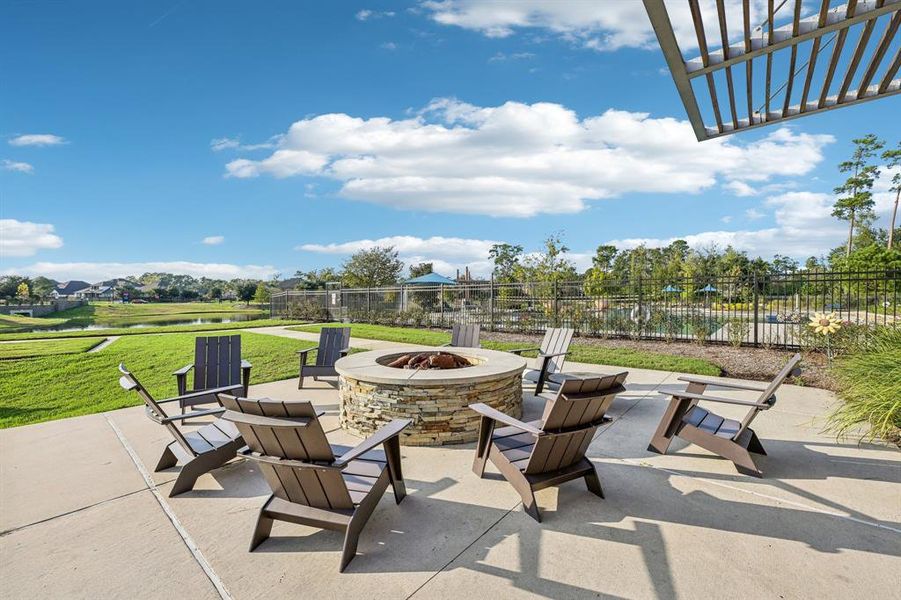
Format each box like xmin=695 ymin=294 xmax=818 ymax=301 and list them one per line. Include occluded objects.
xmin=3 ymin=261 xmax=277 ymax=281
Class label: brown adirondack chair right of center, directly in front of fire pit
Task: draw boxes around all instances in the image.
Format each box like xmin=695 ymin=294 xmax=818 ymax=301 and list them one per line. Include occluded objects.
xmin=469 ymin=373 xmax=628 ymax=522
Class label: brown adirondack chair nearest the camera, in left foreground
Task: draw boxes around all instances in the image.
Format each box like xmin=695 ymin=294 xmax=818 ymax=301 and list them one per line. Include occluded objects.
xmin=219 ymin=394 xmax=411 ymax=571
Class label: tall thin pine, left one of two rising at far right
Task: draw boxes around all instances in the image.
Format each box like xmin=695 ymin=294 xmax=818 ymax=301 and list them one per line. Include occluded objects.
xmin=832 ymin=133 xmax=885 ymax=256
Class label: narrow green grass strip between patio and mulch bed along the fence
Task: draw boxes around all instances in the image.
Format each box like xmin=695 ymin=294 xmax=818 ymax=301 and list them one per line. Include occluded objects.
xmin=288 ymin=324 xmax=721 ymax=376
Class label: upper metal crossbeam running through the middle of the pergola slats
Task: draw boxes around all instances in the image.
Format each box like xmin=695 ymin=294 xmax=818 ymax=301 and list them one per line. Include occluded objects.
xmin=685 ymin=0 xmax=901 ymax=79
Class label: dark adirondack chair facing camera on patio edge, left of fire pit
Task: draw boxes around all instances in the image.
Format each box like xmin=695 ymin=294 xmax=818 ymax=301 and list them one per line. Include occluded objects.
xmin=173 ymin=335 xmax=251 ymax=412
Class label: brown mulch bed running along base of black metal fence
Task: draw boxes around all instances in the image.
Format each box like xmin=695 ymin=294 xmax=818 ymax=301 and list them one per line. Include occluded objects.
xmin=482 ymin=331 xmax=835 ymax=390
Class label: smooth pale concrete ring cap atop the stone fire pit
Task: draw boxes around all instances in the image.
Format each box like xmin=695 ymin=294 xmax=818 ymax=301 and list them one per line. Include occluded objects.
xmin=335 ymin=346 xmax=526 ymax=386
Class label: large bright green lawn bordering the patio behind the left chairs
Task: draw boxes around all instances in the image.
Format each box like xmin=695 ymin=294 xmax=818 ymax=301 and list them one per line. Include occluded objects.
xmin=0 ymin=332 xmax=313 ymax=428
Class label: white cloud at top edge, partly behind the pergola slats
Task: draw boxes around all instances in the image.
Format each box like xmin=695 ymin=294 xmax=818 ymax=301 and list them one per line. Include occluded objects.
xmin=421 ymin=0 xmax=766 ymax=51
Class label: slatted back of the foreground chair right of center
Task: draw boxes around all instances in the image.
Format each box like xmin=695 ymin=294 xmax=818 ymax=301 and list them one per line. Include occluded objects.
xmin=525 ymin=373 xmax=627 ymax=474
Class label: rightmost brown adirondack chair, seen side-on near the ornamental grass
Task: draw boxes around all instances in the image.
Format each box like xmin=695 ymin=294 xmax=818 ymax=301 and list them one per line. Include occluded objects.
xmin=648 ymin=354 xmax=801 ymax=477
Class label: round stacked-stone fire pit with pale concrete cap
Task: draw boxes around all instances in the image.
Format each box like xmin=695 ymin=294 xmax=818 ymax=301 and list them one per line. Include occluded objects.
xmin=335 ymin=347 xmax=526 ymax=446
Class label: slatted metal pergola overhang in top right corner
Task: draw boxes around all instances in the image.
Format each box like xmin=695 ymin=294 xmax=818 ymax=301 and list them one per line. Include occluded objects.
xmin=643 ymin=0 xmax=901 ymax=141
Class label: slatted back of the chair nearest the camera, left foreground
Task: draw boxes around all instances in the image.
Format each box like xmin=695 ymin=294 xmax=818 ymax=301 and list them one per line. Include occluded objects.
xmin=219 ymin=394 xmax=353 ymax=510
